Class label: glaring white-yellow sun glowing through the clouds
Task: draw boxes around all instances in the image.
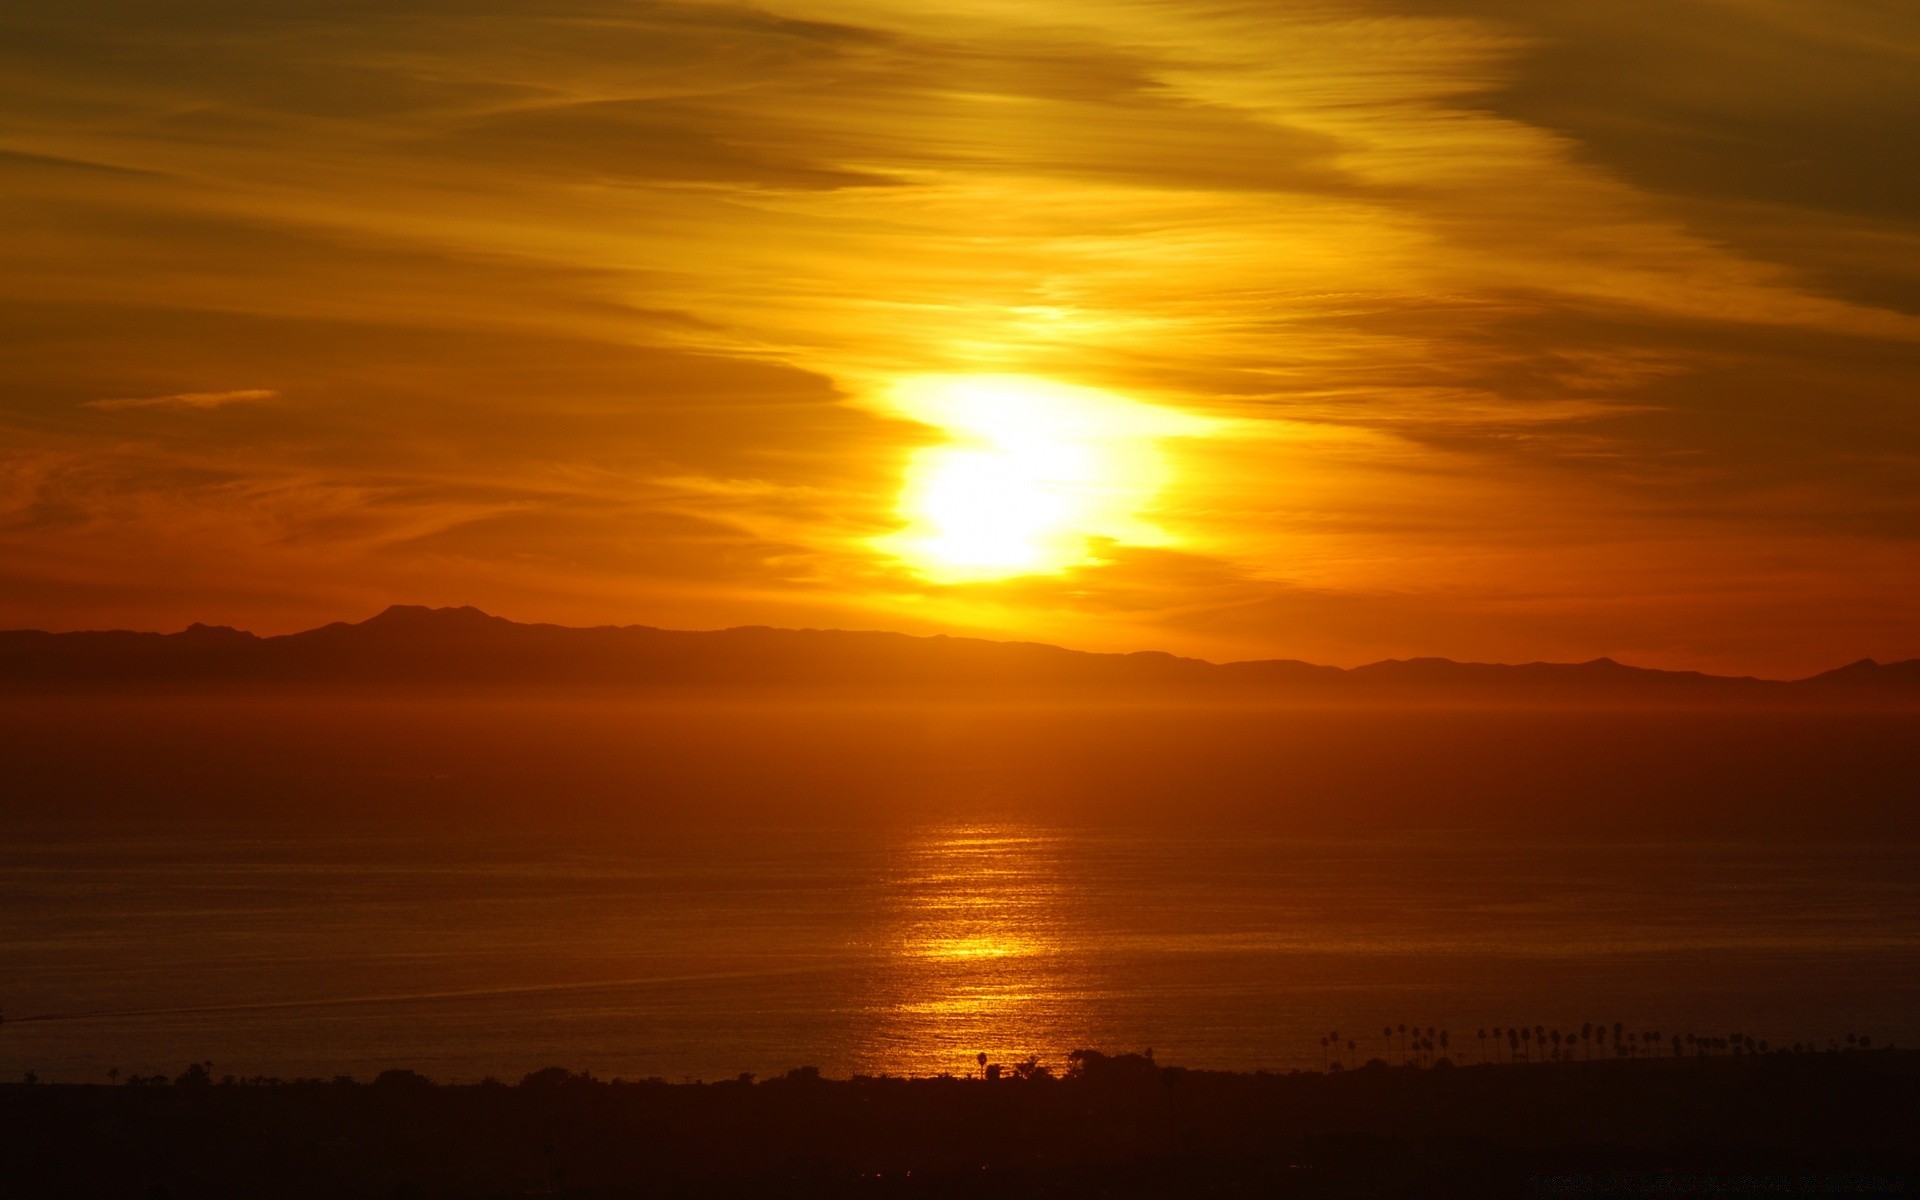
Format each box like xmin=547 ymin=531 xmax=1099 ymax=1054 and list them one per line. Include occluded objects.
xmin=876 ymin=374 xmax=1210 ymax=584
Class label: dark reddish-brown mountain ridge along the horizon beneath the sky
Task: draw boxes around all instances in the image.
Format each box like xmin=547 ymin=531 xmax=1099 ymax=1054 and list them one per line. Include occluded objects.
xmin=0 ymin=605 xmax=1920 ymax=707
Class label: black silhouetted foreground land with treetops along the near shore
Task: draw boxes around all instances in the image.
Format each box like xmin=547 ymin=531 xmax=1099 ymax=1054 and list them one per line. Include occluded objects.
xmin=0 ymin=1050 xmax=1920 ymax=1200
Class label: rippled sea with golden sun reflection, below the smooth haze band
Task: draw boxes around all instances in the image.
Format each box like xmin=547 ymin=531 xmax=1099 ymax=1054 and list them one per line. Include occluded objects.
xmin=0 ymin=820 xmax=1920 ymax=1079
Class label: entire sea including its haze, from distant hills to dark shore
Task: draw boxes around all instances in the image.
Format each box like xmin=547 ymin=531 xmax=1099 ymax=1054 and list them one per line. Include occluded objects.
xmin=0 ymin=701 xmax=1920 ymax=1079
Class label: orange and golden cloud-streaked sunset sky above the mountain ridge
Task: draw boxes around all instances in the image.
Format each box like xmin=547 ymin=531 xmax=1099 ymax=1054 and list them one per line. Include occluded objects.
xmin=0 ymin=0 xmax=1920 ymax=676
